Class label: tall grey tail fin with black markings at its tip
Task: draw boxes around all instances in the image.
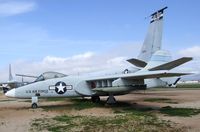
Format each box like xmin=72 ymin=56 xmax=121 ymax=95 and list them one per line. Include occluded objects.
xmin=138 ymin=7 xmax=167 ymax=62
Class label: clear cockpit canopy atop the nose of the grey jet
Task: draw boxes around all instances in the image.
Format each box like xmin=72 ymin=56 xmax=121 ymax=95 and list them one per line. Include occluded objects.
xmin=35 ymin=72 xmax=67 ymax=82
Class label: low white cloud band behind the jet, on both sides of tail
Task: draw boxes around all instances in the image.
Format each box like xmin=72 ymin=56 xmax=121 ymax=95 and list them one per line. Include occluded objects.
xmin=0 ymin=44 xmax=200 ymax=81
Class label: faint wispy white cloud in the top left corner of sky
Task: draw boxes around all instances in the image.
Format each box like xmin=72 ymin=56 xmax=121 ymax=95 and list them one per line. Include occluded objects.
xmin=0 ymin=1 xmax=36 ymax=16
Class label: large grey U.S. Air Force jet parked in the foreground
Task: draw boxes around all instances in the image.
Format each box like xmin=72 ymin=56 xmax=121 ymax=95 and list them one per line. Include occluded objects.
xmin=5 ymin=7 xmax=192 ymax=108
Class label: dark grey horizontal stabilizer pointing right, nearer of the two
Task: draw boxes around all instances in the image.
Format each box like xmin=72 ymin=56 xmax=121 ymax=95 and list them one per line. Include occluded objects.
xmin=149 ymin=57 xmax=192 ymax=71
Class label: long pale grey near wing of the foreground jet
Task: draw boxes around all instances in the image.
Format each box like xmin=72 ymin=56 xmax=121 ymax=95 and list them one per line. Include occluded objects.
xmin=86 ymin=70 xmax=191 ymax=81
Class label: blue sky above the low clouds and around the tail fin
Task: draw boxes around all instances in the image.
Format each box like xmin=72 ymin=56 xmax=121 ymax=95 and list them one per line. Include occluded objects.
xmin=0 ymin=0 xmax=200 ymax=80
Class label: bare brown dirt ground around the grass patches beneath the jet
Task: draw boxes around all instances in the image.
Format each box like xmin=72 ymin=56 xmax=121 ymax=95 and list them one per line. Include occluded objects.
xmin=0 ymin=89 xmax=200 ymax=132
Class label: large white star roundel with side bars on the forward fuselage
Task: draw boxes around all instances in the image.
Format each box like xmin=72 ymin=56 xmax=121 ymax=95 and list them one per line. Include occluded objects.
xmin=49 ymin=81 xmax=73 ymax=94
